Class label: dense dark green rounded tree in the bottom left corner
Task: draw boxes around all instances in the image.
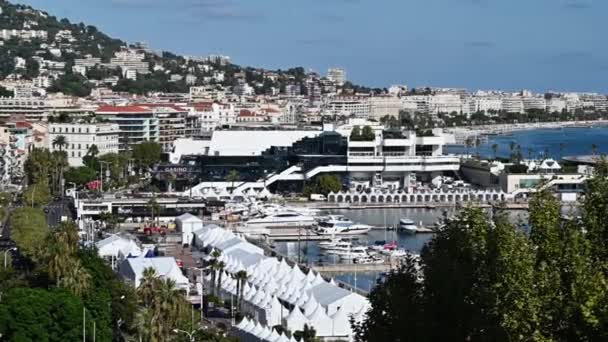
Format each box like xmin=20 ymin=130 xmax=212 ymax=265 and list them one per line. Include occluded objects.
xmin=0 ymin=288 xmax=83 ymax=342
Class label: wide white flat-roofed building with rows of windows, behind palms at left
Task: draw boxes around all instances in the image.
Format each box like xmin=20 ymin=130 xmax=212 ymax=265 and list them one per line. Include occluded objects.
xmin=49 ymin=123 xmax=119 ymax=166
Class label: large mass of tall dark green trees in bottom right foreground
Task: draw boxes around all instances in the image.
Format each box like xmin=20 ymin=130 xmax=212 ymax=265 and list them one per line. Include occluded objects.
xmin=353 ymin=162 xmax=608 ymax=342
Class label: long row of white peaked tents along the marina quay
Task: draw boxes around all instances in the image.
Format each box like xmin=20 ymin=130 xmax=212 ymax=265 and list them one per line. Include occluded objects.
xmin=194 ymin=226 xmax=369 ymax=340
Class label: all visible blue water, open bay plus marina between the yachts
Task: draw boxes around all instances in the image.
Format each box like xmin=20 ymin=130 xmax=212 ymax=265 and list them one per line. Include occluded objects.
xmin=276 ymin=127 xmax=608 ymax=291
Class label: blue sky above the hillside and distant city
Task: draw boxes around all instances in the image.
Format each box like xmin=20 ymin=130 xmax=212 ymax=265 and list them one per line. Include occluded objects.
xmin=13 ymin=0 xmax=608 ymax=93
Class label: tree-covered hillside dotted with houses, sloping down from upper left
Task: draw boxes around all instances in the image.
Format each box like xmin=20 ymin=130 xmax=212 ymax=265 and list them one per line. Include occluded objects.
xmin=0 ymin=0 xmax=379 ymax=96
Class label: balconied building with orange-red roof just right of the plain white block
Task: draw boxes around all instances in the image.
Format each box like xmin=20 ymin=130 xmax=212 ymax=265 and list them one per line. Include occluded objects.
xmin=95 ymin=105 xmax=160 ymax=151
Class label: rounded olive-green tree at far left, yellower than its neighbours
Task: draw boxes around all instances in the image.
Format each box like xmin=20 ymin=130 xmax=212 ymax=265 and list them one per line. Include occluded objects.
xmin=10 ymin=208 xmax=48 ymax=258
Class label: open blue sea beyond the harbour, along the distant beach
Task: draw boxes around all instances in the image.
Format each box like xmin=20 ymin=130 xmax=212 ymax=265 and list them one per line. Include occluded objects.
xmin=448 ymin=127 xmax=608 ymax=159
